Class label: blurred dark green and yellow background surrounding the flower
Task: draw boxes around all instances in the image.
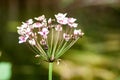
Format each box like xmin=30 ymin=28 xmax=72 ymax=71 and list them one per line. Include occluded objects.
xmin=0 ymin=0 xmax=120 ymax=80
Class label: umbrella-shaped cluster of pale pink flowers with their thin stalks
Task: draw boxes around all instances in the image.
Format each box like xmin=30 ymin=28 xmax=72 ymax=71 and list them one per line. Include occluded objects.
xmin=17 ymin=13 xmax=84 ymax=62
